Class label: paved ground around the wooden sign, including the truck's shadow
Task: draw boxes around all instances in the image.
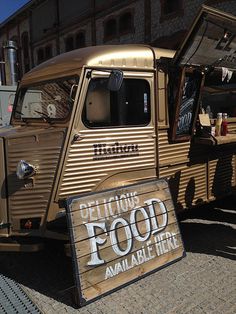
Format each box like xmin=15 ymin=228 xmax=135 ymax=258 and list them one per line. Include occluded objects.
xmin=0 ymin=196 xmax=236 ymax=314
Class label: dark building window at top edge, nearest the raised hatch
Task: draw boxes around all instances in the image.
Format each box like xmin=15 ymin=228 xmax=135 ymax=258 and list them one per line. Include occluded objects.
xmin=160 ymin=0 xmax=183 ymax=22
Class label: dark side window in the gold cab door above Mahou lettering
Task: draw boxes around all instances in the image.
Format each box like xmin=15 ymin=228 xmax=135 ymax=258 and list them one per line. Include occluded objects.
xmin=83 ymin=78 xmax=150 ymax=127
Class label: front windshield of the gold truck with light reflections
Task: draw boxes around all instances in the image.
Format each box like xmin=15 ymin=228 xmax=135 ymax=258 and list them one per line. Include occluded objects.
xmin=14 ymin=78 xmax=78 ymax=121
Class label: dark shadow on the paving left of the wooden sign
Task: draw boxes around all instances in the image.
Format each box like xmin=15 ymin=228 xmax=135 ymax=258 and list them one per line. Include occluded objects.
xmin=0 ymin=241 xmax=74 ymax=306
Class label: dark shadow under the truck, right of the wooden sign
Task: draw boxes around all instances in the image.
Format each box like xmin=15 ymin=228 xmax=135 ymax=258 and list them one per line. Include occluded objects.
xmin=180 ymin=196 xmax=236 ymax=260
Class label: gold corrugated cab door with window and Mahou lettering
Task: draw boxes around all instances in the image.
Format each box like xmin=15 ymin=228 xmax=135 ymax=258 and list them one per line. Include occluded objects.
xmin=58 ymin=70 xmax=156 ymax=198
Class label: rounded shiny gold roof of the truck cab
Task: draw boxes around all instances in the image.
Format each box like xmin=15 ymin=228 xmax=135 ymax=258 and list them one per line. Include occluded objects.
xmin=21 ymin=45 xmax=174 ymax=85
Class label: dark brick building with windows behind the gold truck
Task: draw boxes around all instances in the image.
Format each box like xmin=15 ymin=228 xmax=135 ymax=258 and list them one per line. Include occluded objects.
xmin=0 ymin=0 xmax=236 ymax=81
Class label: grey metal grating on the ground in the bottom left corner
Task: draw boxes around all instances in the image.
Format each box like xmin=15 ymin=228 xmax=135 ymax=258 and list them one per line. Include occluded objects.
xmin=0 ymin=274 xmax=41 ymax=314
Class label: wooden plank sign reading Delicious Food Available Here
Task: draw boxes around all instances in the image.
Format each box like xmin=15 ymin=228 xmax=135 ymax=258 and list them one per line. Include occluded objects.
xmin=67 ymin=179 xmax=185 ymax=306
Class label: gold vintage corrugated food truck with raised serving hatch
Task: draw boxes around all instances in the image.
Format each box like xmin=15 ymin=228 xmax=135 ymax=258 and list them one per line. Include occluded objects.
xmin=0 ymin=7 xmax=236 ymax=251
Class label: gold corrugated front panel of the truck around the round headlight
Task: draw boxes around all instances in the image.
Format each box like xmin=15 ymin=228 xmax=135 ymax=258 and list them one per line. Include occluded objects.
xmin=7 ymin=130 xmax=64 ymax=230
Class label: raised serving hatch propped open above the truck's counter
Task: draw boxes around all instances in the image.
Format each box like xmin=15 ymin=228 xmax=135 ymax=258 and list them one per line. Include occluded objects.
xmin=174 ymin=6 xmax=236 ymax=70
